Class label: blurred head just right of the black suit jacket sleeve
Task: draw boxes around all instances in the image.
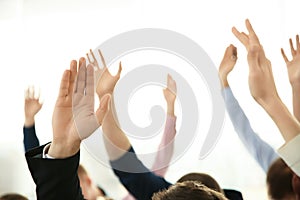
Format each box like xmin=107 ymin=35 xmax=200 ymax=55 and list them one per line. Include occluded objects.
xmin=77 ymin=165 xmax=105 ymax=200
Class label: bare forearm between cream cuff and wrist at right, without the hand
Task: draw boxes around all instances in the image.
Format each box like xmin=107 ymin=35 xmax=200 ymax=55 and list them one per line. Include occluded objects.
xmin=261 ymin=97 xmax=300 ymax=142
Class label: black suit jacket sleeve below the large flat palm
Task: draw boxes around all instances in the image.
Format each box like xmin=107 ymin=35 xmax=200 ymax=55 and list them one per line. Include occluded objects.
xmin=25 ymin=145 xmax=83 ymax=200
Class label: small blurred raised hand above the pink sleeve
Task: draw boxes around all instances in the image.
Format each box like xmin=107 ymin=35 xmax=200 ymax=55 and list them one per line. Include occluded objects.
xmin=163 ymin=74 xmax=177 ymax=116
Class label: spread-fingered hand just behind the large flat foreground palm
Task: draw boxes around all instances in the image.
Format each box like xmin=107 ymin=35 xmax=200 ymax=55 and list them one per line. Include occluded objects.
xmin=86 ymin=49 xmax=122 ymax=99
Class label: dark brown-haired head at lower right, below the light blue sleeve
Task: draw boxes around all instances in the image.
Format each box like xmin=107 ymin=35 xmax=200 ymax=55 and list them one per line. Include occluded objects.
xmin=267 ymin=158 xmax=295 ymax=200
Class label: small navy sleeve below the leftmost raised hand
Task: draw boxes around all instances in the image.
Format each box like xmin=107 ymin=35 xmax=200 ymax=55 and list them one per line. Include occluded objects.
xmin=23 ymin=125 xmax=40 ymax=152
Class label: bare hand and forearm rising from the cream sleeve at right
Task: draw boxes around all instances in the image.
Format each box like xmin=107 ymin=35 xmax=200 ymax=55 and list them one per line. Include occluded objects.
xmin=232 ymin=20 xmax=300 ymax=142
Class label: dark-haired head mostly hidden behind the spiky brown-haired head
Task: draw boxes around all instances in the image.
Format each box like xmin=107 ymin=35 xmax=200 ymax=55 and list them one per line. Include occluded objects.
xmin=177 ymin=173 xmax=223 ymax=193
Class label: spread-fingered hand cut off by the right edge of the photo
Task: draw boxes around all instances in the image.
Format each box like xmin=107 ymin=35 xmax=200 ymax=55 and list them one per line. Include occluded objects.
xmin=281 ymin=35 xmax=300 ymax=86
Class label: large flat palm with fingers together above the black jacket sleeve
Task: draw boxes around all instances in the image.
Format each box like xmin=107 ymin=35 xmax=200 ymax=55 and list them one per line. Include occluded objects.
xmin=48 ymin=58 xmax=107 ymax=158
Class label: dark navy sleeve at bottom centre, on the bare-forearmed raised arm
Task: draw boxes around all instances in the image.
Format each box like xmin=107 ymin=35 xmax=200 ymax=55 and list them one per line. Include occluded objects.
xmin=110 ymin=147 xmax=171 ymax=200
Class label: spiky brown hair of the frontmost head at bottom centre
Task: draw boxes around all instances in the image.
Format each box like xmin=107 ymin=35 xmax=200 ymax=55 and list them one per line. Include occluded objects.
xmin=152 ymin=181 xmax=226 ymax=200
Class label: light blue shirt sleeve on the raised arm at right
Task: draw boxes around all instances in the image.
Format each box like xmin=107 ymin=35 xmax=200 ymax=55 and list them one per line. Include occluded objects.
xmin=222 ymin=87 xmax=278 ymax=172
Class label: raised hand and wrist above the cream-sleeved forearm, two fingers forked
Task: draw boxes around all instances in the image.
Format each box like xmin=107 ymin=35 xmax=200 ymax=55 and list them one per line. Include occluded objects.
xmin=232 ymin=20 xmax=279 ymax=106
